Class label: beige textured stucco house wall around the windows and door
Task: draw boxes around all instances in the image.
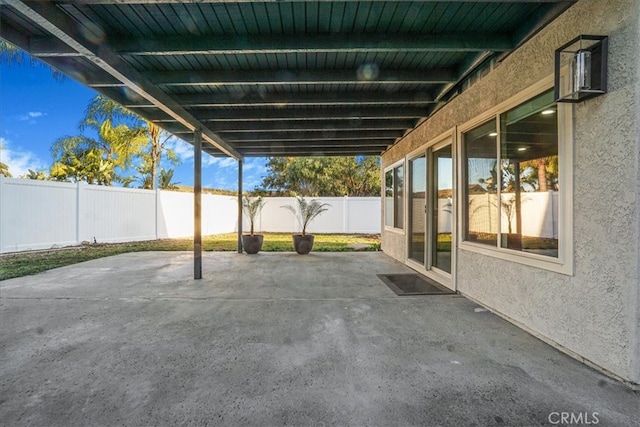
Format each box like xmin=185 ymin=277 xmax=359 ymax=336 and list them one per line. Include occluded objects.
xmin=382 ymin=0 xmax=640 ymax=383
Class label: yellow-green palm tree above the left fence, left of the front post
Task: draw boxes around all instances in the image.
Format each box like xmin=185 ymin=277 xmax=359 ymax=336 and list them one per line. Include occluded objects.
xmin=51 ymin=95 xmax=148 ymax=185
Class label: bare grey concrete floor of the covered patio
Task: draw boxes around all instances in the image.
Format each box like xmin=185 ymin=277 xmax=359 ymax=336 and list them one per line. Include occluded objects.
xmin=0 ymin=252 xmax=640 ymax=426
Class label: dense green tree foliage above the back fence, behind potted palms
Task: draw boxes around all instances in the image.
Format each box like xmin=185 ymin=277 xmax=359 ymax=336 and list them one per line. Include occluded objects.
xmin=256 ymin=156 xmax=380 ymax=197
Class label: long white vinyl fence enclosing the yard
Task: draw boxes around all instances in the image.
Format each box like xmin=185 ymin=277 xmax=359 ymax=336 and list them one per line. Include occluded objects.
xmin=0 ymin=175 xmax=380 ymax=253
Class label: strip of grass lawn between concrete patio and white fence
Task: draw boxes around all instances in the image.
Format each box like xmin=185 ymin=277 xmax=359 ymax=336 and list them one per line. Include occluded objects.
xmin=0 ymin=233 xmax=380 ymax=280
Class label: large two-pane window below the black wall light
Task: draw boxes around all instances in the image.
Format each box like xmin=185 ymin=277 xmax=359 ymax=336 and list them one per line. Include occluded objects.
xmin=462 ymin=91 xmax=568 ymax=259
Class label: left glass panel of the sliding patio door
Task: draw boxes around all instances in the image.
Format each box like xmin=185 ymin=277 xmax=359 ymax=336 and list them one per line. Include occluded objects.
xmin=409 ymin=155 xmax=427 ymax=265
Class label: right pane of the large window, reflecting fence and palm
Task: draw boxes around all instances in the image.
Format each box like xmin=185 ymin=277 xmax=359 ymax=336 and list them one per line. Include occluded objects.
xmin=500 ymin=92 xmax=559 ymax=257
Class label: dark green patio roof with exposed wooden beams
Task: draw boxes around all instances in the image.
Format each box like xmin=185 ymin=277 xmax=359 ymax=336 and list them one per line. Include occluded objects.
xmin=0 ymin=0 xmax=575 ymax=159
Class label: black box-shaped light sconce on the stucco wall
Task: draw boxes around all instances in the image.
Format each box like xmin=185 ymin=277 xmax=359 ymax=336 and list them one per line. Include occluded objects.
xmin=554 ymin=35 xmax=609 ymax=103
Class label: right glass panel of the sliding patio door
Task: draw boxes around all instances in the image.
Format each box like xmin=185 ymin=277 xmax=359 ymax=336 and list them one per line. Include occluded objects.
xmin=430 ymin=144 xmax=453 ymax=273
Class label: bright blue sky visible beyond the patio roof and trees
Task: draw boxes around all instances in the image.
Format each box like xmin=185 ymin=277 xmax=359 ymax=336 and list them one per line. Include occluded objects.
xmin=0 ymin=63 xmax=266 ymax=190
